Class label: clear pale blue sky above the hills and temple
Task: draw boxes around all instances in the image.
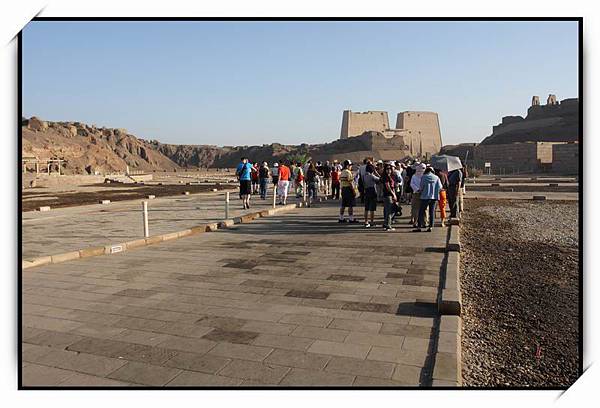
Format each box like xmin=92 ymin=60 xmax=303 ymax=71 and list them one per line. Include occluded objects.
xmin=23 ymin=21 xmax=578 ymax=145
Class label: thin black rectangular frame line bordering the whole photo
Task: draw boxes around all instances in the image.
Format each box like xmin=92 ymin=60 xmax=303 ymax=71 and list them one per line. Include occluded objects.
xmin=16 ymin=16 xmax=584 ymax=391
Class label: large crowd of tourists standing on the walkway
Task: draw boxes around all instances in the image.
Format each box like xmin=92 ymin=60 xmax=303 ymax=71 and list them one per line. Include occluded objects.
xmin=236 ymin=157 xmax=467 ymax=232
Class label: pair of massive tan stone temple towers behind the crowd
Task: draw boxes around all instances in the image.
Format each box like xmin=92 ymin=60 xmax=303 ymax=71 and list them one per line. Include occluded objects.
xmin=340 ymin=110 xmax=442 ymax=157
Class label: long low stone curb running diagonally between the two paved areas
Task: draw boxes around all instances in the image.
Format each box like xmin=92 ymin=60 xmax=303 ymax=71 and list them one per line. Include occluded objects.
xmin=21 ymin=204 xmax=297 ymax=269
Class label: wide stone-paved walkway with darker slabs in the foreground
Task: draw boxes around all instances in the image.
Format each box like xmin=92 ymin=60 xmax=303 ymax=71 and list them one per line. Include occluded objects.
xmin=22 ymin=202 xmax=446 ymax=387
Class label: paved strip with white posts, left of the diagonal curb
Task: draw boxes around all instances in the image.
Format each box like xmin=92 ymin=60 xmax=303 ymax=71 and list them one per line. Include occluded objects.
xmin=22 ymin=190 xmax=295 ymax=259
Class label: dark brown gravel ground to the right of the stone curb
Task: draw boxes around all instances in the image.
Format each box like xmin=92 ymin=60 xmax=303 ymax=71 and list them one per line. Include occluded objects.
xmin=461 ymin=200 xmax=579 ymax=387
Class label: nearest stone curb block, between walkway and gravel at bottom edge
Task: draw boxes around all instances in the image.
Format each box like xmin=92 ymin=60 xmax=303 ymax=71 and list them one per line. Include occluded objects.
xmin=431 ymin=316 xmax=462 ymax=387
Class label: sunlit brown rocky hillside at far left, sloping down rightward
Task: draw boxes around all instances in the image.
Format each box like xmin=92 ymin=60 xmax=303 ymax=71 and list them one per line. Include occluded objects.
xmin=22 ymin=117 xmax=180 ymax=174
